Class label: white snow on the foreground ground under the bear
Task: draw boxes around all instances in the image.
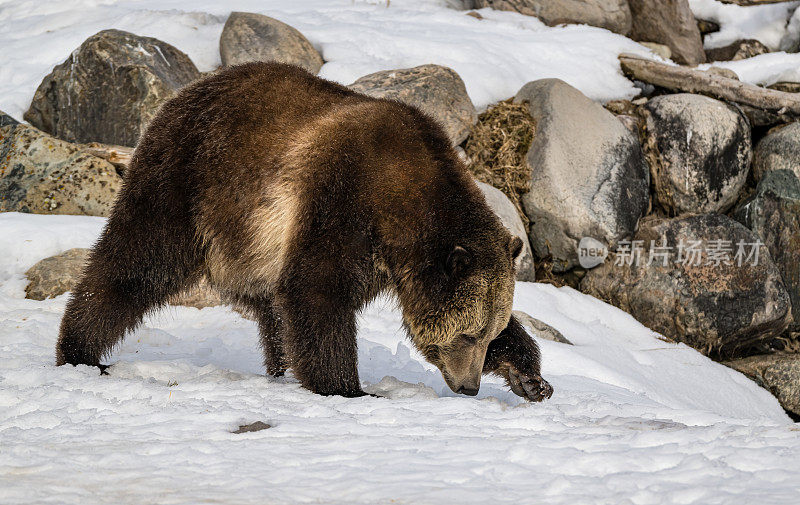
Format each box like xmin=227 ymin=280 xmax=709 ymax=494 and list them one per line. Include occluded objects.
xmin=0 ymin=213 xmax=800 ymax=505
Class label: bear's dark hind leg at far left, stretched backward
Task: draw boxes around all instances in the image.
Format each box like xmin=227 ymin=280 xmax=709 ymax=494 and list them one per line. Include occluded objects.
xmin=56 ymin=188 xmax=201 ymax=366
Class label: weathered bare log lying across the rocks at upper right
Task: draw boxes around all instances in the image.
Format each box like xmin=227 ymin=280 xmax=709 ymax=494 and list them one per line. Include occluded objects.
xmin=619 ymin=54 xmax=800 ymax=121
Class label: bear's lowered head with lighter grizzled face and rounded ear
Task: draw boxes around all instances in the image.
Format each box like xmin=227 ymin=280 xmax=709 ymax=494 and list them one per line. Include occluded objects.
xmin=398 ymin=215 xmax=523 ymax=395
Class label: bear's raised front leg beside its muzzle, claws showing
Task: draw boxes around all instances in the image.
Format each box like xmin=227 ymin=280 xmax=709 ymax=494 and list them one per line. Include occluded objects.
xmin=483 ymin=316 xmax=553 ymax=402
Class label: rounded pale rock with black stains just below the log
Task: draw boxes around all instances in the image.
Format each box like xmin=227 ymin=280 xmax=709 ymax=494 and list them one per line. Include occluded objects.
xmin=642 ymin=94 xmax=751 ymax=215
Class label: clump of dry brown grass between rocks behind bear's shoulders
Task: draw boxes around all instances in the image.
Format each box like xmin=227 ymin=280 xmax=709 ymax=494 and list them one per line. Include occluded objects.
xmin=464 ymin=100 xmax=536 ymax=229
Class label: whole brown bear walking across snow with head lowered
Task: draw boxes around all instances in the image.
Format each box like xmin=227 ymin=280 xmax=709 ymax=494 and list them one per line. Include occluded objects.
xmin=56 ymin=63 xmax=552 ymax=401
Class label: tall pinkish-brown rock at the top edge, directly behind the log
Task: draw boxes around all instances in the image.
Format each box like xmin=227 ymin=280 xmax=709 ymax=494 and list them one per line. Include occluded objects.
xmin=629 ymin=0 xmax=706 ymax=65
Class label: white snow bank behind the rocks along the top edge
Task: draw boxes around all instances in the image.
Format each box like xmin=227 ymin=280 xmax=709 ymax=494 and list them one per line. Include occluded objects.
xmin=0 ymin=0 xmax=800 ymax=120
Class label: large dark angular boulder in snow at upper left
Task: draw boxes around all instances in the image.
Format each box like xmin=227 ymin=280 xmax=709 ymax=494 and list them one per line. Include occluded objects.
xmin=25 ymin=30 xmax=200 ymax=146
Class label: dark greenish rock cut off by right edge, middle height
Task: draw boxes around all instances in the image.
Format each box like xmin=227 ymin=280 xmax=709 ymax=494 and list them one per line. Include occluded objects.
xmin=733 ymin=170 xmax=800 ymax=331
